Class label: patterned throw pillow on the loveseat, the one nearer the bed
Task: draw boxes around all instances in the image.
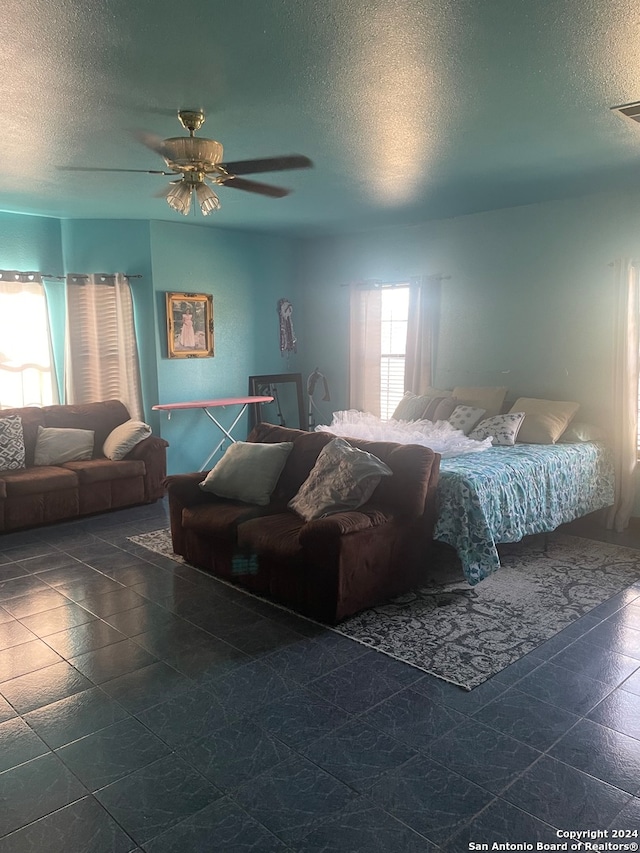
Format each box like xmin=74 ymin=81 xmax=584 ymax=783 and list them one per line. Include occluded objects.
xmin=288 ymin=438 xmax=393 ymax=521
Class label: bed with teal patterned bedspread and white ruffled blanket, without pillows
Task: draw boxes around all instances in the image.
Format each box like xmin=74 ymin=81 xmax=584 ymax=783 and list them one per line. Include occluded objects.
xmin=316 ymin=410 xmax=614 ymax=585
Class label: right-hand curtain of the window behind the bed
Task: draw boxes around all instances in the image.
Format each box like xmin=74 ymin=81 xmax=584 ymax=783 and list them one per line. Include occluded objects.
xmin=404 ymin=275 xmax=441 ymax=394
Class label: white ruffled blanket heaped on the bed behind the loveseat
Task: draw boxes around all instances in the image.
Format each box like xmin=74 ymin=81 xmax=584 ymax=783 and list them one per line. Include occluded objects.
xmin=316 ymin=409 xmax=491 ymax=459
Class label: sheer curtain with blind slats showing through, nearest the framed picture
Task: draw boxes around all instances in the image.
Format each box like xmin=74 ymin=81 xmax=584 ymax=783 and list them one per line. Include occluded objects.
xmin=65 ymin=273 xmax=143 ymax=420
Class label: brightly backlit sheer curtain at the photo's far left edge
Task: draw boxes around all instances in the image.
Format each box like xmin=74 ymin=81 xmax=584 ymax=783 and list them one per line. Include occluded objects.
xmin=0 ymin=270 xmax=58 ymax=409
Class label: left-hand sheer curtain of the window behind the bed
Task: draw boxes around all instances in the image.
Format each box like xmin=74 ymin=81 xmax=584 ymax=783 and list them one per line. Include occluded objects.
xmin=349 ymin=284 xmax=382 ymax=417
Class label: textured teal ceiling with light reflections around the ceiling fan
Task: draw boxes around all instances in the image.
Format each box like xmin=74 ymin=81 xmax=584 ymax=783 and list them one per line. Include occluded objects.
xmin=0 ymin=0 xmax=640 ymax=233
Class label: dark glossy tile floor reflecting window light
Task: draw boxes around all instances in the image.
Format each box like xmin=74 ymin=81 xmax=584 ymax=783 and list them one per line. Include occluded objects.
xmin=0 ymin=503 xmax=640 ymax=853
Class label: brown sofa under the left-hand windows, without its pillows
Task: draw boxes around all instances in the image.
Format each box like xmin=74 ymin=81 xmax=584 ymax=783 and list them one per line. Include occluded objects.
xmin=0 ymin=400 xmax=168 ymax=533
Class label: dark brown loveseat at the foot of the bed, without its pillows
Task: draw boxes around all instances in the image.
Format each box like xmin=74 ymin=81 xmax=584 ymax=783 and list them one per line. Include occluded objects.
xmin=166 ymin=423 xmax=440 ymax=624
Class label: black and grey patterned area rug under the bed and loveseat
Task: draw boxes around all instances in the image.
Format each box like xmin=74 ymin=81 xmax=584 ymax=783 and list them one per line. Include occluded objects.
xmin=131 ymin=530 xmax=640 ymax=690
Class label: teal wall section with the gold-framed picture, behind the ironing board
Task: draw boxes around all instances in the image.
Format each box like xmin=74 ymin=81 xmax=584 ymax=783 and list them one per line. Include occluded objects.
xmin=151 ymin=222 xmax=296 ymax=471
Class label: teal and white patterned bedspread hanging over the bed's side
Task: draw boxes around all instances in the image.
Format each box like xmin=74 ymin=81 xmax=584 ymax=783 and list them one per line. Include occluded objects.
xmin=434 ymin=441 xmax=614 ymax=584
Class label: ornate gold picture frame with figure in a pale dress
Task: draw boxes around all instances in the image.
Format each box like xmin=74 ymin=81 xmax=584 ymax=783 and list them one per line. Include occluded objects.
xmin=166 ymin=292 xmax=214 ymax=358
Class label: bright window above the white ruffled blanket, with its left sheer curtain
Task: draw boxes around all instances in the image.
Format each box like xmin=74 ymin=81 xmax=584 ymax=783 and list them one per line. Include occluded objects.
xmin=349 ymin=282 xmax=409 ymax=419
